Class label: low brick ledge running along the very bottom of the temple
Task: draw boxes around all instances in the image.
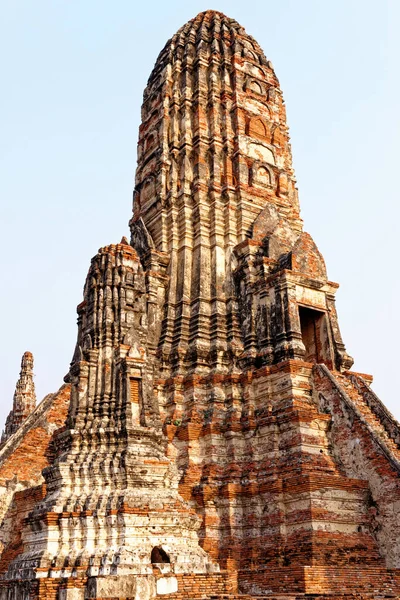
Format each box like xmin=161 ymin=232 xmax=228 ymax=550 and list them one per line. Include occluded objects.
xmin=0 ymin=566 xmax=400 ymax=600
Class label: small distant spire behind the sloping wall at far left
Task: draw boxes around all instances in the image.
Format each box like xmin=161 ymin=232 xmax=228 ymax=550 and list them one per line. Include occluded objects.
xmin=1 ymin=352 xmax=36 ymax=443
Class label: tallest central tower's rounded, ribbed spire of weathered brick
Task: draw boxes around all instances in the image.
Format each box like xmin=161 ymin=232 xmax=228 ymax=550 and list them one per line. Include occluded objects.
xmin=131 ymin=11 xmax=301 ymax=372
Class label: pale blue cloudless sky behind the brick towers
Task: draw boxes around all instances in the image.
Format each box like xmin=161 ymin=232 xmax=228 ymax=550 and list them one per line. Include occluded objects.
xmin=0 ymin=0 xmax=400 ymax=423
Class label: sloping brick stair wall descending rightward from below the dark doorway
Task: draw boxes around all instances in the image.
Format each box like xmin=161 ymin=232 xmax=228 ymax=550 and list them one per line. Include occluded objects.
xmin=315 ymin=367 xmax=400 ymax=568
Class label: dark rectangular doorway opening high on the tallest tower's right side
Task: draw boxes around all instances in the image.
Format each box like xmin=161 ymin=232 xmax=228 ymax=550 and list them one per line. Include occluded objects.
xmin=299 ymin=306 xmax=332 ymax=366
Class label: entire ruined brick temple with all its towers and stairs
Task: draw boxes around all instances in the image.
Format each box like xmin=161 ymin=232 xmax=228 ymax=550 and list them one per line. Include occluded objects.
xmin=0 ymin=11 xmax=400 ymax=600
